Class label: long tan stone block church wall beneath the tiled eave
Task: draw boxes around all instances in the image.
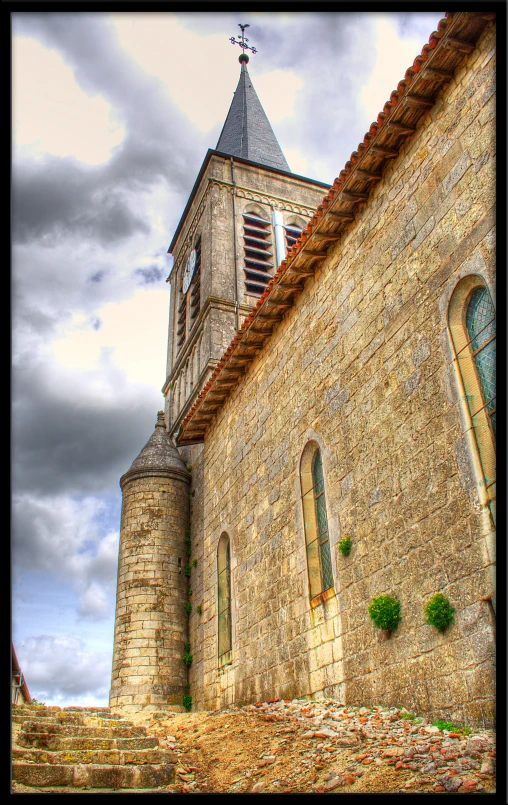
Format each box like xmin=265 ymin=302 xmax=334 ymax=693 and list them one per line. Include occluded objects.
xmin=186 ymin=22 xmax=495 ymax=724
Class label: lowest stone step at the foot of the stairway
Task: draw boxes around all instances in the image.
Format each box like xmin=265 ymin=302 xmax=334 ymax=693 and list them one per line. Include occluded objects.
xmin=12 ymin=762 xmax=175 ymax=790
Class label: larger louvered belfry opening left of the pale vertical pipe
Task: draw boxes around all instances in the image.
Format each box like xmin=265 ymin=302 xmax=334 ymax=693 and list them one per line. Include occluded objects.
xmin=243 ymin=212 xmax=274 ymax=297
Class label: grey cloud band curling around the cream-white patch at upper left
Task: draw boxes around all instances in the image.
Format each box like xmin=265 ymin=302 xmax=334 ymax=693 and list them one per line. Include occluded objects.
xmin=12 ymin=13 xmax=206 ymax=245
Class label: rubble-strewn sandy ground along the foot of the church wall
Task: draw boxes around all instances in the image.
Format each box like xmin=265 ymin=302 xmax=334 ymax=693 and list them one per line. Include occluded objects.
xmin=136 ymin=699 xmax=495 ymax=793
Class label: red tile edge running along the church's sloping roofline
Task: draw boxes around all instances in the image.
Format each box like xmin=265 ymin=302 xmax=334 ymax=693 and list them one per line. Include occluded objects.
xmin=180 ymin=11 xmax=484 ymax=432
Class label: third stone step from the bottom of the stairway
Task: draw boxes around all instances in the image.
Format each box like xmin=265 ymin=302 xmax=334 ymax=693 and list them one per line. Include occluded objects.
xmin=17 ymin=727 xmax=159 ymax=752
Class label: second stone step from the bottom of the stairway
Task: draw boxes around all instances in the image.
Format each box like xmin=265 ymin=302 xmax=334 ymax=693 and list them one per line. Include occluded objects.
xmin=12 ymin=747 xmax=178 ymax=766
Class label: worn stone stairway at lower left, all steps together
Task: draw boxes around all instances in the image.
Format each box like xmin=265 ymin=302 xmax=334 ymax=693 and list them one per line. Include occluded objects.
xmin=12 ymin=705 xmax=177 ymax=793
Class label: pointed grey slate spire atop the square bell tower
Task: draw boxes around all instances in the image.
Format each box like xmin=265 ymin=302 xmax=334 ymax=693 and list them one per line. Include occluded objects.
xmin=216 ymin=61 xmax=290 ymax=171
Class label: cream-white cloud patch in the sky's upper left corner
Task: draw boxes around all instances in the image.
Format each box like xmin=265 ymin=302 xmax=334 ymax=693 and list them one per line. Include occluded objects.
xmin=12 ymin=37 xmax=125 ymax=165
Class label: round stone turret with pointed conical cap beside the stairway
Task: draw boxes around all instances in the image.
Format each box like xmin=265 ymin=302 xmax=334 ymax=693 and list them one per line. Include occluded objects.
xmin=109 ymin=411 xmax=190 ymax=714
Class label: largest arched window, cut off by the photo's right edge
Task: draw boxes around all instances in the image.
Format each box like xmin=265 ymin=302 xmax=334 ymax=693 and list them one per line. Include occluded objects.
xmin=448 ymin=275 xmax=496 ymax=523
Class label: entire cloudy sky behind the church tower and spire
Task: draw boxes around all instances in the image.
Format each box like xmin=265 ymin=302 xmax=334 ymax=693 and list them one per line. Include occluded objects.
xmin=12 ymin=12 xmax=444 ymax=706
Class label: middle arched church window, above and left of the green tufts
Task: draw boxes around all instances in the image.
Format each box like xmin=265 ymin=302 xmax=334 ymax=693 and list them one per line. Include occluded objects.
xmin=300 ymin=442 xmax=333 ymax=599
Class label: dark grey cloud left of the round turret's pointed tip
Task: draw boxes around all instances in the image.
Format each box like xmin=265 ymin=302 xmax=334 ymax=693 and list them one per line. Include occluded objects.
xmin=12 ymin=350 xmax=160 ymax=495
